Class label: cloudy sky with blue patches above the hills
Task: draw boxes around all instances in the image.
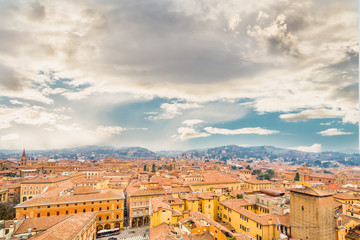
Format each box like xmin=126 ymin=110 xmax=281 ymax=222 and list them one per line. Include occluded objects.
xmin=0 ymin=0 xmax=359 ymax=151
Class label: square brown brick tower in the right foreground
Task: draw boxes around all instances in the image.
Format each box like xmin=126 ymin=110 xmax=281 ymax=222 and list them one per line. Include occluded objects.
xmin=290 ymin=187 xmax=335 ymax=240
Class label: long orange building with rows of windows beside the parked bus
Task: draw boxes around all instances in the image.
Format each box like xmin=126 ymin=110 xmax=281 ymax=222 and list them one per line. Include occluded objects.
xmin=15 ymin=182 xmax=125 ymax=230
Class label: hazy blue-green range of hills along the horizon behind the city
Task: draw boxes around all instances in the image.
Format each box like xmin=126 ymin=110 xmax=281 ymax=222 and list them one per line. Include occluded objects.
xmin=0 ymin=145 xmax=360 ymax=165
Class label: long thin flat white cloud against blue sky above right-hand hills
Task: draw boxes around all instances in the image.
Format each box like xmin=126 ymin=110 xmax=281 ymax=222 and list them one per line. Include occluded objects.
xmin=204 ymin=127 xmax=279 ymax=135
